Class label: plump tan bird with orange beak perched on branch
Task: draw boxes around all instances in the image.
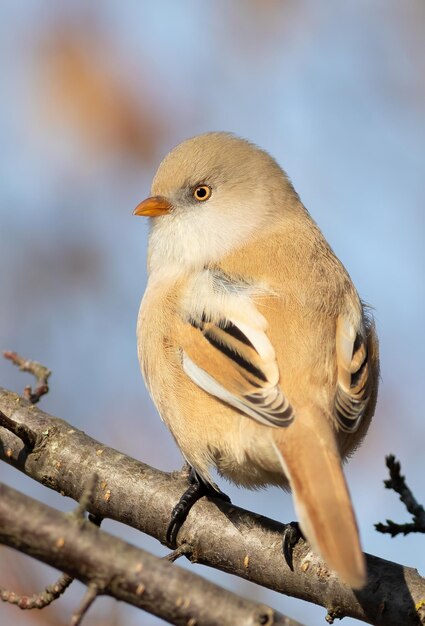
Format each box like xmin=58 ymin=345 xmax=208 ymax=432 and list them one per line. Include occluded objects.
xmin=134 ymin=132 xmax=379 ymax=589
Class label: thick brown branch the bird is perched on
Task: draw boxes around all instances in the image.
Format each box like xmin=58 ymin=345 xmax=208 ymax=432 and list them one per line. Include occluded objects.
xmin=0 ymin=390 xmax=425 ymax=626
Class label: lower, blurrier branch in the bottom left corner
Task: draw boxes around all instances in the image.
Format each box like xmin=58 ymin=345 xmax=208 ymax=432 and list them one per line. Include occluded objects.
xmin=0 ymin=483 xmax=301 ymax=626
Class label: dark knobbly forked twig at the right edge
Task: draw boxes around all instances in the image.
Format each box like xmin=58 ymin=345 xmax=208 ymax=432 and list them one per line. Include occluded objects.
xmin=375 ymin=454 xmax=425 ymax=537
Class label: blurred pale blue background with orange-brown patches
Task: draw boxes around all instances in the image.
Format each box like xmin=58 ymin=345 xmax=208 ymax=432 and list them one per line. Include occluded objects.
xmin=0 ymin=0 xmax=425 ymax=626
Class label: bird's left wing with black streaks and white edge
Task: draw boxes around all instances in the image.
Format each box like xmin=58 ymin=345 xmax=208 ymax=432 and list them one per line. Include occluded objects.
xmin=179 ymin=270 xmax=294 ymax=426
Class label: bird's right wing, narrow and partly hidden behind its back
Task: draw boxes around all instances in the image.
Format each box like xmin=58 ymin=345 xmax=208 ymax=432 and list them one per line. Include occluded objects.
xmin=335 ymin=316 xmax=373 ymax=433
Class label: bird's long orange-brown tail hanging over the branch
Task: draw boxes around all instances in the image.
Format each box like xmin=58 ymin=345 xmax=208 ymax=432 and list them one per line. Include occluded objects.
xmin=274 ymin=409 xmax=366 ymax=589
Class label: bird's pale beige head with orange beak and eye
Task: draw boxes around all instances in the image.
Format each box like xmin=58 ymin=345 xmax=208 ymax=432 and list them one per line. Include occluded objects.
xmin=134 ymin=132 xmax=297 ymax=269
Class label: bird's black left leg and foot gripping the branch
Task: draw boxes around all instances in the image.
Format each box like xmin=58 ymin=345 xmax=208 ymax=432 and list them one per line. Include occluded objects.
xmin=166 ymin=467 xmax=230 ymax=546
